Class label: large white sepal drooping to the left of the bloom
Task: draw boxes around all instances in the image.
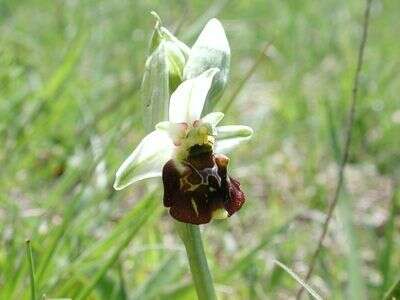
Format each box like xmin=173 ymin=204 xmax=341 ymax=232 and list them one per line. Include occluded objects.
xmin=114 ymin=130 xmax=173 ymax=190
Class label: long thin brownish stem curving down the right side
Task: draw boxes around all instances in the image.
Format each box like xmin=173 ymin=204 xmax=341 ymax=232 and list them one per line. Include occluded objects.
xmin=296 ymin=0 xmax=372 ymax=299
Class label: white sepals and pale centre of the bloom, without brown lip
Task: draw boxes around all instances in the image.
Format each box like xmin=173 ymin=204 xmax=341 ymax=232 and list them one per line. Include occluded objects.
xmin=114 ymin=68 xmax=253 ymax=190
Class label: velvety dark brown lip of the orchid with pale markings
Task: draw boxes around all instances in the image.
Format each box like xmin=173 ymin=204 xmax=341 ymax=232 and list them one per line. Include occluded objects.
xmin=162 ymin=151 xmax=245 ymax=224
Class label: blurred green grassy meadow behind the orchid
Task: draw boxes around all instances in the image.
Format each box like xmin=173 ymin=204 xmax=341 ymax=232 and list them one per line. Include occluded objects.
xmin=0 ymin=0 xmax=400 ymax=299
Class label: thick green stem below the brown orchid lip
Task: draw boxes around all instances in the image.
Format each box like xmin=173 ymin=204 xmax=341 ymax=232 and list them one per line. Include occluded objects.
xmin=176 ymin=222 xmax=217 ymax=300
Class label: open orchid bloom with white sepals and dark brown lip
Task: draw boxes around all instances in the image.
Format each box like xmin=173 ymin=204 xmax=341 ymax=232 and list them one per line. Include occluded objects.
xmin=114 ymin=68 xmax=253 ymax=224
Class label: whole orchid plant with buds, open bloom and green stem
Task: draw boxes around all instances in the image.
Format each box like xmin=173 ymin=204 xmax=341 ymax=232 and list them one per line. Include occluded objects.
xmin=114 ymin=15 xmax=253 ymax=299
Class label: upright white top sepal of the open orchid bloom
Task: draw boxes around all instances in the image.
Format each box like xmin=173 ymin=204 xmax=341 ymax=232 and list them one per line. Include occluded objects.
xmin=169 ymin=68 xmax=219 ymax=123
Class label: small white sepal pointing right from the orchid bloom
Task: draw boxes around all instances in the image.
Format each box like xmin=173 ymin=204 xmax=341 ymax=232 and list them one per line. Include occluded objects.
xmin=214 ymin=125 xmax=253 ymax=153
